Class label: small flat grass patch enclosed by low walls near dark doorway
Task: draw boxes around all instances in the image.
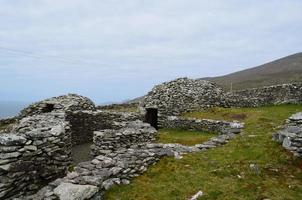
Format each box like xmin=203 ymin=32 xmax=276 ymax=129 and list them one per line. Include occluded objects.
xmin=157 ymin=129 xmax=216 ymax=146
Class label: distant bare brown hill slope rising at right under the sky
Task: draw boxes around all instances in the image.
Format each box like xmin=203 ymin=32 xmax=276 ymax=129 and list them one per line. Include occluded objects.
xmin=203 ymin=53 xmax=302 ymax=90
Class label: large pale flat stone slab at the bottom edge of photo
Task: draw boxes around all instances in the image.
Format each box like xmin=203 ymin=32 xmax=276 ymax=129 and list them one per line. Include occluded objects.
xmin=54 ymin=183 xmax=99 ymax=200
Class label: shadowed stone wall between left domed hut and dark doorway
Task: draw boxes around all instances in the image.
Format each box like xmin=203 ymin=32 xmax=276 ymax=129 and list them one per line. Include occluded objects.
xmin=66 ymin=110 xmax=142 ymax=145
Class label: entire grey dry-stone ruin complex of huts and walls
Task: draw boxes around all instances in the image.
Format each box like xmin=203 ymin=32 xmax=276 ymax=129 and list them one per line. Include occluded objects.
xmin=0 ymin=78 xmax=302 ymax=200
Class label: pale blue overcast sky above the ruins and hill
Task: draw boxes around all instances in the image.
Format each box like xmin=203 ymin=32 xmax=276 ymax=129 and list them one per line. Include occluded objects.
xmin=0 ymin=0 xmax=302 ymax=103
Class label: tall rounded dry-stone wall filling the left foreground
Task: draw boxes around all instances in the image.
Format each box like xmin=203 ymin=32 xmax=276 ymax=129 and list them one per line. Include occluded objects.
xmin=0 ymin=113 xmax=71 ymax=199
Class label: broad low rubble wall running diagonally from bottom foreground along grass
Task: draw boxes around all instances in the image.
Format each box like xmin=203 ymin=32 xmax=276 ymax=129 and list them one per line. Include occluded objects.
xmin=20 ymin=127 xmax=241 ymax=200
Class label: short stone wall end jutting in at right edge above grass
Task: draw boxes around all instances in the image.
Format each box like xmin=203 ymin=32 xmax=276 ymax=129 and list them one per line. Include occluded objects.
xmin=273 ymin=113 xmax=302 ymax=158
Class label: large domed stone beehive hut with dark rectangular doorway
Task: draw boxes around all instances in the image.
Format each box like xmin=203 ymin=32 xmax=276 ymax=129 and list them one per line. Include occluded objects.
xmin=140 ymin=78 xmax=225 ymax=128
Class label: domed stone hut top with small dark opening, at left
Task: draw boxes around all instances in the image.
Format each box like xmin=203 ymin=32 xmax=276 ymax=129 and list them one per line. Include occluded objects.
xmin=19 ymin=94 xmax=95 ymax=118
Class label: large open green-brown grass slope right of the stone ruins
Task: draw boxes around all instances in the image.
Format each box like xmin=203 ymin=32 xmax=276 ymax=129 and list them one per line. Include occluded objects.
xmin=105 ymin=105 xmax=302 ymax=200
